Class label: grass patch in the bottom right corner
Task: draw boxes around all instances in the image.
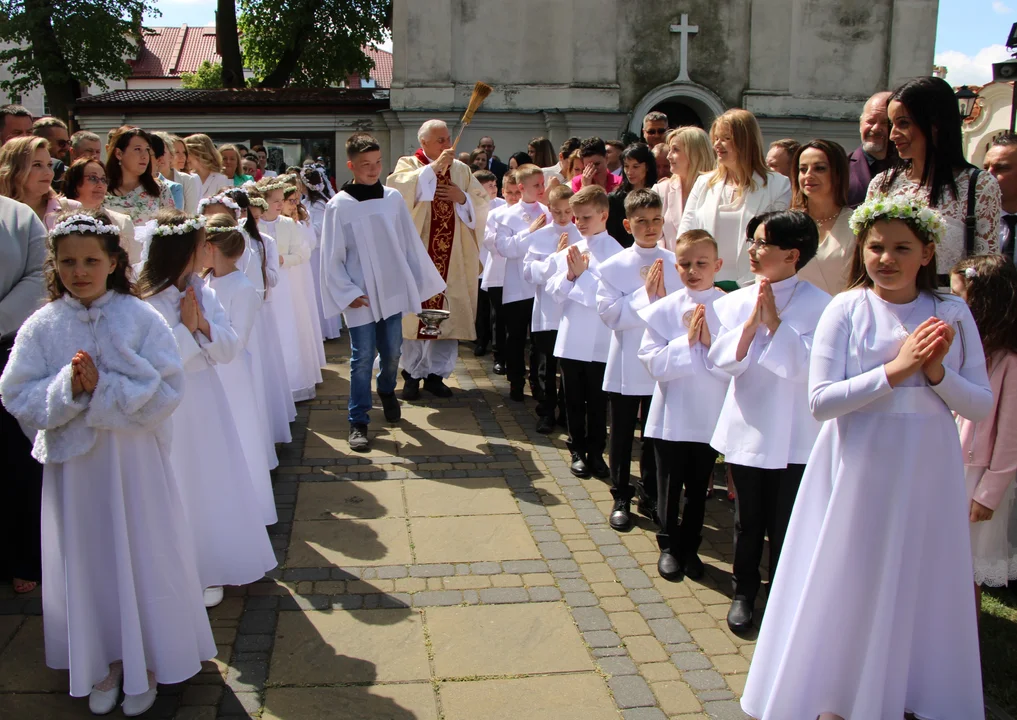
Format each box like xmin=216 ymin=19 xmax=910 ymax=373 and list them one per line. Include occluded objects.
xmin=980 ymin=588 xmax=1017 ymax=716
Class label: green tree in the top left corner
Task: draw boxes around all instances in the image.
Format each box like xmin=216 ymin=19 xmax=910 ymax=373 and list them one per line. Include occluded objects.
xmin=0 ymin=0 xmax=154 ymax=119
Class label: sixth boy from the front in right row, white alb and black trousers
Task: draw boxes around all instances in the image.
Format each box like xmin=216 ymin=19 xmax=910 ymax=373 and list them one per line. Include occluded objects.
xmin=494 ymin=164 xmax=551 ymax=403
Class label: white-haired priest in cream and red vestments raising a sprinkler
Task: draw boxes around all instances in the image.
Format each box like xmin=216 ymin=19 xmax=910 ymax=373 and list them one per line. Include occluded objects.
xmin=385 ymin=120 xmax=487 ymax=400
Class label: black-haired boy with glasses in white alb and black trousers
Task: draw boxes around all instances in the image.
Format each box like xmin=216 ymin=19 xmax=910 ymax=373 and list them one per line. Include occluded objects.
xmin=709 ymin=211 xmax=830 ymax=633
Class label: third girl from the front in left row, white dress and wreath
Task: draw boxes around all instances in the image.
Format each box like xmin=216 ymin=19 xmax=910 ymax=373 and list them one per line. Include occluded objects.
xmin=204 ymin=213 xmax=279 ymax=525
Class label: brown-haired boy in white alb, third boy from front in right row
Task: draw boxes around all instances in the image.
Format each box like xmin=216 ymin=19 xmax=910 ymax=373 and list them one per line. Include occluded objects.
xmin=597 ymin=190 xmax=681 ymax=530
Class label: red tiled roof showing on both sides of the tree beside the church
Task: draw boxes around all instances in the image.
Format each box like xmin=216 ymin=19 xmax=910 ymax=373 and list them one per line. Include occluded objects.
xmin=131 ymin=25 xmax=392 ymax=87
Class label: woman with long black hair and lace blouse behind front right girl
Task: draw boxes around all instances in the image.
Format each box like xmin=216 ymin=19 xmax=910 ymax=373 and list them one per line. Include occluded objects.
xmin=868 ymin=77 xmax=1001 ymax=280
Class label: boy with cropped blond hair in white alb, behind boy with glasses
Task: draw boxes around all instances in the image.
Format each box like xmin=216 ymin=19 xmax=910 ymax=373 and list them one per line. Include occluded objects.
xmin=639 ymin=230 xmax=731 ymax=583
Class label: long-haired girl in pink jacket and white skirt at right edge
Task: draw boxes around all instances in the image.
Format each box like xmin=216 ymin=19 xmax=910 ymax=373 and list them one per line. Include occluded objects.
xmin=950 ymin=255 xmax=1017 ymax=609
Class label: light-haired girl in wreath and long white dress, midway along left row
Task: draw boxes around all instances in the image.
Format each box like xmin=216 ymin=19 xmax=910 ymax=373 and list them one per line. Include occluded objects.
xmin=257 ymin=178 xmax=324 ymax=403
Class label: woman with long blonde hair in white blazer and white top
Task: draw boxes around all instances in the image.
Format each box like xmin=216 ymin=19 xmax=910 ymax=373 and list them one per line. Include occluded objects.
xmin=678 ymin=109 xmax=791 ymax=290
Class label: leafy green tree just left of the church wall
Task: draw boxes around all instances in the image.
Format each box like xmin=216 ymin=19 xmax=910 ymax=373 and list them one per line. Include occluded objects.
xmin=238 ymin=0 xmax=392 ymax=87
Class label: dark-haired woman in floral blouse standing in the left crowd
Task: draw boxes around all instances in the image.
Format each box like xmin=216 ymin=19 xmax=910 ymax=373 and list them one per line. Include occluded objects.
xmin=106 ymin=127 xmax=174 ymax=225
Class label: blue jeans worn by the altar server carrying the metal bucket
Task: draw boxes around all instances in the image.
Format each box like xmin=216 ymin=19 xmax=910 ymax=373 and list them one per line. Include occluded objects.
xmin=350 ymin=312 xmax=403 ymax=425
